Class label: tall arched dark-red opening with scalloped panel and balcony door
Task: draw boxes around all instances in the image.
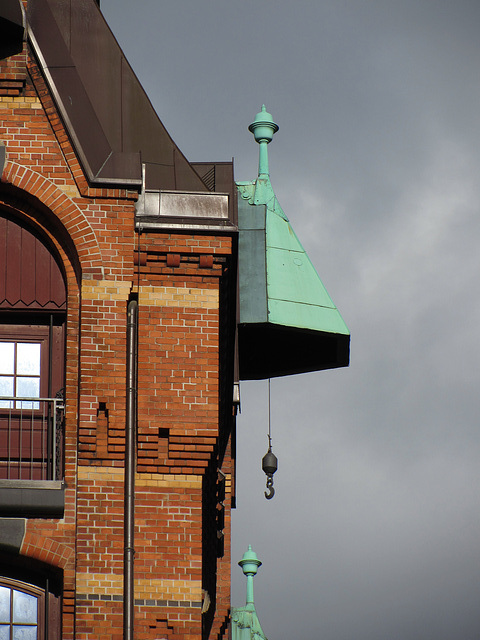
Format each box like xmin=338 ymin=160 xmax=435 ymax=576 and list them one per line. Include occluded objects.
xmin=0 ymin=215 xmax=67 ymax=480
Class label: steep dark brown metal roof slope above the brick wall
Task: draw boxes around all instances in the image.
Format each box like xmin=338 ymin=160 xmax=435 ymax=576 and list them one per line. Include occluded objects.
xmin=27 ymin=0 xmax=207 ymax=191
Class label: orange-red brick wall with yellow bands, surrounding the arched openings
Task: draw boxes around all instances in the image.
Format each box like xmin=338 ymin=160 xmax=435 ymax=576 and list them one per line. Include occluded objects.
xmin=0 ymin=32 xmax=235 ymax=640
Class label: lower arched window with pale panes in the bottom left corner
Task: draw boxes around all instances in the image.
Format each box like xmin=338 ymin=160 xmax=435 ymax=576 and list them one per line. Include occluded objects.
xmin=0 ymin=581 xmax=43 ymax=640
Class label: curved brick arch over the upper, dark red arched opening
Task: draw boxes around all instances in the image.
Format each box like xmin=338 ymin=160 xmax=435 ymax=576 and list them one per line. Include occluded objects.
xmin=2 ymin=161 xmax=103 ymax=279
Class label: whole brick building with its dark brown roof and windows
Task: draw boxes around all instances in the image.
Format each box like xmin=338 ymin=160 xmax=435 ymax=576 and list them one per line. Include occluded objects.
xmin=0 ymin=0 xmax=348 ymax=640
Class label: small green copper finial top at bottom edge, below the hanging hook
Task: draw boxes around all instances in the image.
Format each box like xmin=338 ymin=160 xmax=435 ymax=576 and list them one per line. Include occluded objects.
xmin=231 ymin=545 xmax=267 ymax=640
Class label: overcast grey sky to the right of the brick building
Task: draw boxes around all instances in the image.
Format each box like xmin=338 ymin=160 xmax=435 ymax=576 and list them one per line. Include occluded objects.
xmin=101 ymin=0 xmax=480 ymax=640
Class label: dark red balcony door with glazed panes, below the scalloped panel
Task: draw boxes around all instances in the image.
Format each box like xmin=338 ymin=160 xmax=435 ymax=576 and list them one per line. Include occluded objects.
xmin=0 ymin=324 xmax=64 ymax=480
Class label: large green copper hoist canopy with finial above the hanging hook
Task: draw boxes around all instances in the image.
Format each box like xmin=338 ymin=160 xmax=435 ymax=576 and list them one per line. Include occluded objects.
xmin=236 ymin=106 xmax=350 ymax=379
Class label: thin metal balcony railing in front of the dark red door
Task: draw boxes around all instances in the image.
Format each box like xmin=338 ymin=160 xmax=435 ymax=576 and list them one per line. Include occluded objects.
xmin=0 ymin=396 xmax=64 ymax=480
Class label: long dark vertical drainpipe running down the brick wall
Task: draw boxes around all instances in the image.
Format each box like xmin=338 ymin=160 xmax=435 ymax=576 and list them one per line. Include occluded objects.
xmin=123 ymin=299 xmax=138 ymax=640
